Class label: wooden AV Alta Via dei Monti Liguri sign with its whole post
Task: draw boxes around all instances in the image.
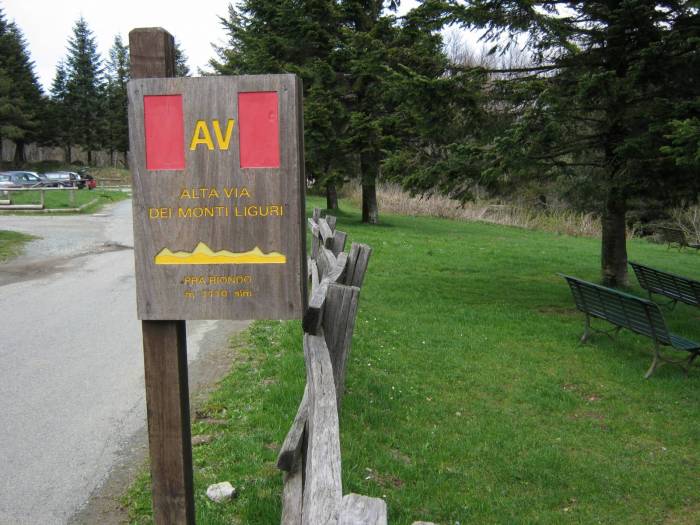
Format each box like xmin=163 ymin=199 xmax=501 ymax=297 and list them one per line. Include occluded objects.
xmin=128 ymin=29 xmax=307 ymax=524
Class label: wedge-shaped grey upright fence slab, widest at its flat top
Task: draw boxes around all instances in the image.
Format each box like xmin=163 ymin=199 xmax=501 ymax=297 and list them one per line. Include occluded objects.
xmin=322 ymin=284 xmax=360 ymax=413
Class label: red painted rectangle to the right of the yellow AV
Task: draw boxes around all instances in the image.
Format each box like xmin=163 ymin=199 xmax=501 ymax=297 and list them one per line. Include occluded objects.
xmin=238 ymin=91 xmax=280 ymax=168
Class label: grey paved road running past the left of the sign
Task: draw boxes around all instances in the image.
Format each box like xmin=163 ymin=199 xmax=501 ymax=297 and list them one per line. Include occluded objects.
xmin=0 ymin=201 xmax=246 ymax=525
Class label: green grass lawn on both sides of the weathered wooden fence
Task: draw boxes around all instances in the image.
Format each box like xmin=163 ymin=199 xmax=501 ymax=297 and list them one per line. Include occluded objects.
xmin=126 ymin=198 xmax=700 ymax=525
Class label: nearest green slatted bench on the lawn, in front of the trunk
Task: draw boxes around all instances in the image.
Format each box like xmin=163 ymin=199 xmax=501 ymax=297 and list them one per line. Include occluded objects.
xmin=562 ymin=275 xmax=700 ymax=378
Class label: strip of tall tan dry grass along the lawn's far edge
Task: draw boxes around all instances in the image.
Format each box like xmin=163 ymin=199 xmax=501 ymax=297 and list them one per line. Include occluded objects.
xmin=342 ymin=184 xmax=604 ymax=237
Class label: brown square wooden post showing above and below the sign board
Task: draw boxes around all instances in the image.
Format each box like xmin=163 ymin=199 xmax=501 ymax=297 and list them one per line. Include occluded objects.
xmin=129 ymin=28 xmax=194 ymax=525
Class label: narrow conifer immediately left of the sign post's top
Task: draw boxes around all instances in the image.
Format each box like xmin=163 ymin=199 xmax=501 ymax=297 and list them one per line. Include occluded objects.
xmin=105 ymin=35 xmax=129 ymax=158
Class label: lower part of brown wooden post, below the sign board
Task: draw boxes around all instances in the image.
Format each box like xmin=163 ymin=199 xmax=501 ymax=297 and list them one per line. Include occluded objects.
xmin=142 ymin=321 xmax=194 ymax=525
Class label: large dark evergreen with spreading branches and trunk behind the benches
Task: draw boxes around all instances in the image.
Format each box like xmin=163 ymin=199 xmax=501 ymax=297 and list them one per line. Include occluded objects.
xmin=426 ymin=0 xmax=700 ymax=286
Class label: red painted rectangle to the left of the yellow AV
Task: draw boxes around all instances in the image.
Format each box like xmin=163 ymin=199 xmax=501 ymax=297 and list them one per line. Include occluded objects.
xmin=143 ymin=95 xmax=185 ymax=170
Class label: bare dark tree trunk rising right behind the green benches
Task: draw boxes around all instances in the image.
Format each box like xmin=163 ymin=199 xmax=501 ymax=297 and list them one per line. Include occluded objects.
xmin=601 ymin=190 xmax=627 ymax=287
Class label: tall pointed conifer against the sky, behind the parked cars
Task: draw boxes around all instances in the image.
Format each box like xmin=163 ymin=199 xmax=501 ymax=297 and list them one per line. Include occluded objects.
xmin=64 ymin=17 xmax=106 ymax=163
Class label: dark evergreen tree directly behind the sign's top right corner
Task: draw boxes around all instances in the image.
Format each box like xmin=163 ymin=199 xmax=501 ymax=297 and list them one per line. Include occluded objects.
xmin=210 ymin=0 xmax=348 ymax=209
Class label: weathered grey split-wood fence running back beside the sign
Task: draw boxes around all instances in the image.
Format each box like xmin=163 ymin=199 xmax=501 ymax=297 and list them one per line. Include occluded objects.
xmin=277 ymin=209 xmax=432 ymax=525
